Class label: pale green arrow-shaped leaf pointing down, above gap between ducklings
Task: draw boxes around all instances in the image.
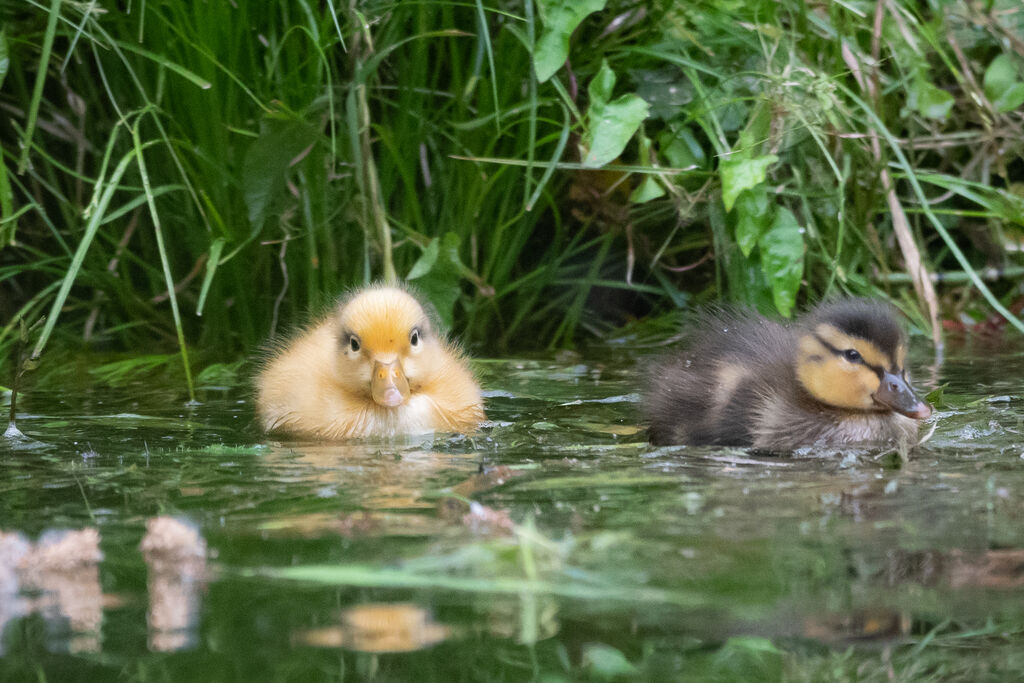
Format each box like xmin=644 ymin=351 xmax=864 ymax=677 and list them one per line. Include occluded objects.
xmin=583 ymin=61 xmax=650 ymax=168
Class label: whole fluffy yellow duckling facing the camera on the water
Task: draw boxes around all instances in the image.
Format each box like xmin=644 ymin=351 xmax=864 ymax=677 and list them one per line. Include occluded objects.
xmin=256 ymin=286 xmax=484 ymax=439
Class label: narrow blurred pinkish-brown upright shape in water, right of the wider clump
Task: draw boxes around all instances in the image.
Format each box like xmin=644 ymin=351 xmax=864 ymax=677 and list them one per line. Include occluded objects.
xmin=139 ymin=517 xmax=207 ymax=652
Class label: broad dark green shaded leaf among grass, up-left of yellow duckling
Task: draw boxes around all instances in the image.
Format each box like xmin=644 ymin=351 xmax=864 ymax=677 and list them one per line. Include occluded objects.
xmin=242 ymin=116 xmax=317 ymax=229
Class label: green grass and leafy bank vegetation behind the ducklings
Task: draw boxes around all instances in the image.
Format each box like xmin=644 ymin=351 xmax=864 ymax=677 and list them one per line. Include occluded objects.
xmin=0 ymin=0 xmax=1024 ymax=378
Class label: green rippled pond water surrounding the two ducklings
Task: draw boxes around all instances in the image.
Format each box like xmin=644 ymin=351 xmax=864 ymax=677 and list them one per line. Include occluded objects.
xmin=0 ymin=342 xmax=1024 ymax=681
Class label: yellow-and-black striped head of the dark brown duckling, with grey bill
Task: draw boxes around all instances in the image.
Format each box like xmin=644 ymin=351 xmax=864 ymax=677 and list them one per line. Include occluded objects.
xmin=797 ymin=299 xmax=932 ymax=420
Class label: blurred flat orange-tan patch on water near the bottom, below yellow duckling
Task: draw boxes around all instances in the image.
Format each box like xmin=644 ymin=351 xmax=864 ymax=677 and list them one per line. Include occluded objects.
xmin=295 ymin=602 xmax=450 ymax=653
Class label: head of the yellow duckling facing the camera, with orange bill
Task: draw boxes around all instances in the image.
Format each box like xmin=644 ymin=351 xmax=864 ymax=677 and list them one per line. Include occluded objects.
xmin=336 ymin=287 xmax=443 ymax=408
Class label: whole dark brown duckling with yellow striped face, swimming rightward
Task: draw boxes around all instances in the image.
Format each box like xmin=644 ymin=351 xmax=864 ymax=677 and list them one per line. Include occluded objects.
xmin=644 ymin=299 xmax=932 ymax=451
